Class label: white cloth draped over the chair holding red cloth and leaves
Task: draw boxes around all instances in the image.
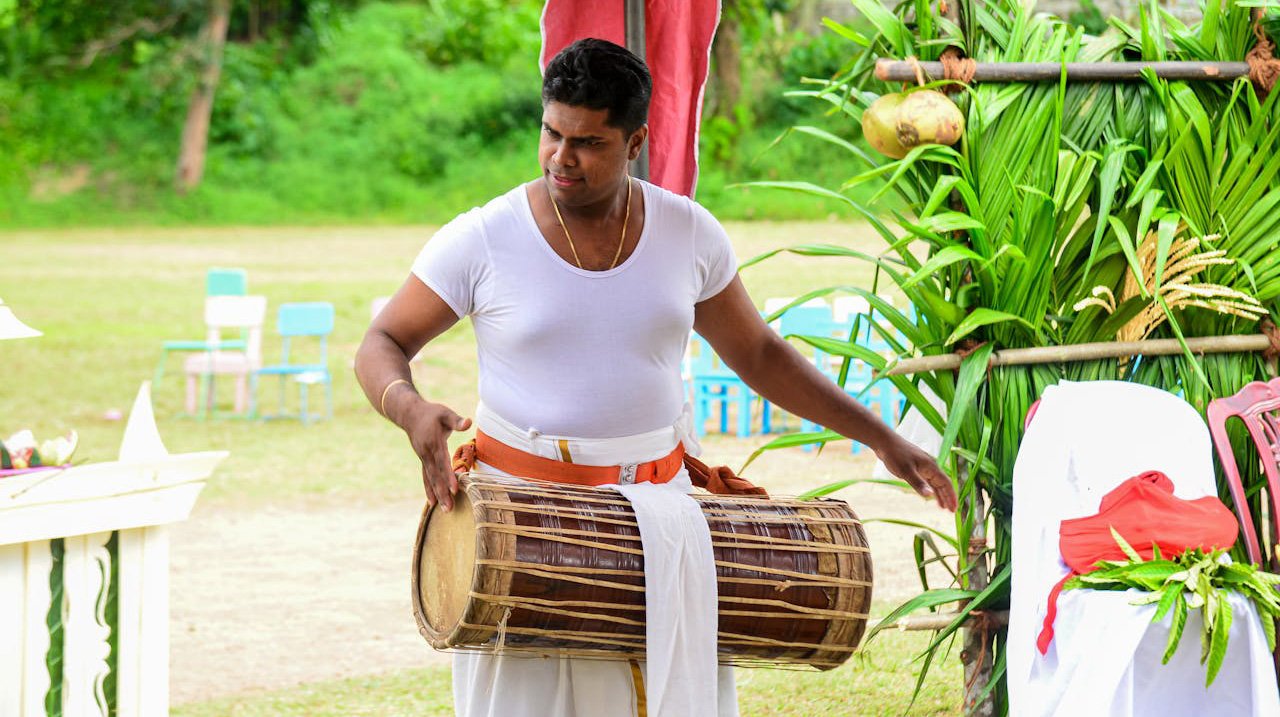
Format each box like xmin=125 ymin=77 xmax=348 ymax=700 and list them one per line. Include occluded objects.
xmin=1007 ymin=382 xmax=1280 ymax=717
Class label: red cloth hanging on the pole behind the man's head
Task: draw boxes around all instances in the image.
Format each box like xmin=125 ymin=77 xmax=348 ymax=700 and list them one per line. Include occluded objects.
xmin=541 ymin=0 xmax=719 ymax=197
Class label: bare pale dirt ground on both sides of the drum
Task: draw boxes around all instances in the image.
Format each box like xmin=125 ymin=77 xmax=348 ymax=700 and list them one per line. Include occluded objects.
xmin=170 ymin=473 xmax=950 ymax=704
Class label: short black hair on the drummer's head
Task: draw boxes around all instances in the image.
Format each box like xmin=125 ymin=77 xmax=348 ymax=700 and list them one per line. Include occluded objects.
xmin=543 ymin=37 xmax=653 ymax=136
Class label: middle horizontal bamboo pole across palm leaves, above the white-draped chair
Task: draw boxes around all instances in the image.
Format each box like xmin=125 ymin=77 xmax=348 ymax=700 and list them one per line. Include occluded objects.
xmin=884 ymin=334 xmax=1271 ymax=376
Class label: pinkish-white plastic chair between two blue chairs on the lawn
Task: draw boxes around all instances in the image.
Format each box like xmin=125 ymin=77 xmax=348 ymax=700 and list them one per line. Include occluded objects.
xmin=183 ymin=296 xmax=266 ymax=416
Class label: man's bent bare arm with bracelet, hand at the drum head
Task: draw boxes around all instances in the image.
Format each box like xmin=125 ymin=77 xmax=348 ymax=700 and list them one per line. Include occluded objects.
xmin=356 ymin=277 xmax=471 ymax=510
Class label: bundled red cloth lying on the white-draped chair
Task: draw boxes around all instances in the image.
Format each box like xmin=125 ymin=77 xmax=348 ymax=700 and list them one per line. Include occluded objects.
xmin=1036 ymin=471 xmax=1240 ymax=654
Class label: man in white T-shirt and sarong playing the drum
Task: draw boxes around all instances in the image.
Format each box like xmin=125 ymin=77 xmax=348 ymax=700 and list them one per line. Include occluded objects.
xmin=356 ymin=40 xmax=956 ymax=717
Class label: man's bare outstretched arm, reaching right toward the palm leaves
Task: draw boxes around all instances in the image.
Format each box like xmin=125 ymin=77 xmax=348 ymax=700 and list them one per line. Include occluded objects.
xmin=694 ymin=277 xmax=956 ymax=511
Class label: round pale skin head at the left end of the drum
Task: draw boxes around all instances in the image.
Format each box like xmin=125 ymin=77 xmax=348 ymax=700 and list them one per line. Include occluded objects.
xmin=417 ymin=490 xmax=476 ymax=636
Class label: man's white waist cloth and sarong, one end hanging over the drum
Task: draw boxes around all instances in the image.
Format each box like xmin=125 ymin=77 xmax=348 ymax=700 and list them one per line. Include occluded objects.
xmin=453 ymin=406 xmax=737 ymax=717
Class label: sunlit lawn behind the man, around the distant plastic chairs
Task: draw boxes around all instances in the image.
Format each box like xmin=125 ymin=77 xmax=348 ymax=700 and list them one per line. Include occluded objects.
xmin=0 ymin=223 xmax=869 ymax=503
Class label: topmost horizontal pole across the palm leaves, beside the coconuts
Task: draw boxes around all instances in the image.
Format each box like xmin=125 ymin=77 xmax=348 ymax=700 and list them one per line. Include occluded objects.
xmin=876 ymin=58 xmax=1249 ymax=82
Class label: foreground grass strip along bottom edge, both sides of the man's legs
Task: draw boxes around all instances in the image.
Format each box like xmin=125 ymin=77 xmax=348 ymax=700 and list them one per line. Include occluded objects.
xmin=173 ymin=631 xmax=961 ymax=717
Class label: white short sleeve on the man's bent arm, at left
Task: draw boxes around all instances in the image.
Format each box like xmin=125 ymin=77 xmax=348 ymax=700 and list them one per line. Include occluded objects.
xmin=413 ymin=210 xmax=486 ymax=319
